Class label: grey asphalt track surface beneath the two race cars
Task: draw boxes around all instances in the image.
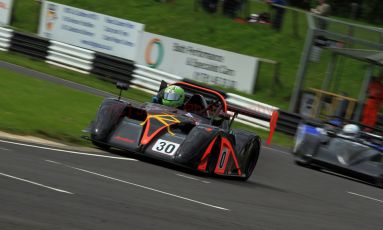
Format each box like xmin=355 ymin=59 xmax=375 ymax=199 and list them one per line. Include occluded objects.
xmin=0 ymin=60 xmax=383 ymax=230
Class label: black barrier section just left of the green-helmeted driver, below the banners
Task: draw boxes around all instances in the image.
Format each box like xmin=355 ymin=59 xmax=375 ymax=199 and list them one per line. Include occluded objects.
xmin=91 ymin=53 xmax=135 ymax=82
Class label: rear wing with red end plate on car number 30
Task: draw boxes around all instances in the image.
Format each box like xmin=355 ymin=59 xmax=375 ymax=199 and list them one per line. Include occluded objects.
xmin=228 ymin=103 xmax=279 ymax=145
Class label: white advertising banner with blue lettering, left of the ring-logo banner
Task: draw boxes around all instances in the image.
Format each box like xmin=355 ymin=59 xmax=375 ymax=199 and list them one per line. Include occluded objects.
xmin=39 ymin=1 xmax=144 ymax=60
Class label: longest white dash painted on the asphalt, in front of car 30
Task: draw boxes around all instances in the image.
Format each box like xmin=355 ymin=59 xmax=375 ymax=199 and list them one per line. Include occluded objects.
xmin=45 ymin=160 xmax=230 ymax=211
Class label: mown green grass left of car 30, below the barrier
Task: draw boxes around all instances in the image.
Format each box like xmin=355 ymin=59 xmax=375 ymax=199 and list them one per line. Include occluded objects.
xmin=0 ymin=69 xmax=103 ymax=144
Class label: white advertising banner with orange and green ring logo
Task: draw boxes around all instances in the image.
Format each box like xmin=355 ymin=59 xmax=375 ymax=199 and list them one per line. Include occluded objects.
xmin=137 ymin=32 xmax=258 ymax=93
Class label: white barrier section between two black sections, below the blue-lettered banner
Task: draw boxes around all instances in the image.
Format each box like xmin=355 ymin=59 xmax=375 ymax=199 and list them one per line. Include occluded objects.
xmin=46 ymin=41 xmax=95 ymax=74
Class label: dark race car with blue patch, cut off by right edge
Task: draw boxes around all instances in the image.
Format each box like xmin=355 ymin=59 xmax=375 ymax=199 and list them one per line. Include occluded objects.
xmin=293 ymin=121 xmax=383 ymax=187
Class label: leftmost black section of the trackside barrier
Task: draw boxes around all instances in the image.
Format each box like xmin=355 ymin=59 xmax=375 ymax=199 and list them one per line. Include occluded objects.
xmin=9 ymin=31 xmax=50 ymax=60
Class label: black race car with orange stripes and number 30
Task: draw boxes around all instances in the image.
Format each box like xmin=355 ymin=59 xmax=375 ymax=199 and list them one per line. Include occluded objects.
xmin=87 ymin=82 xmax=268 ymax=180
